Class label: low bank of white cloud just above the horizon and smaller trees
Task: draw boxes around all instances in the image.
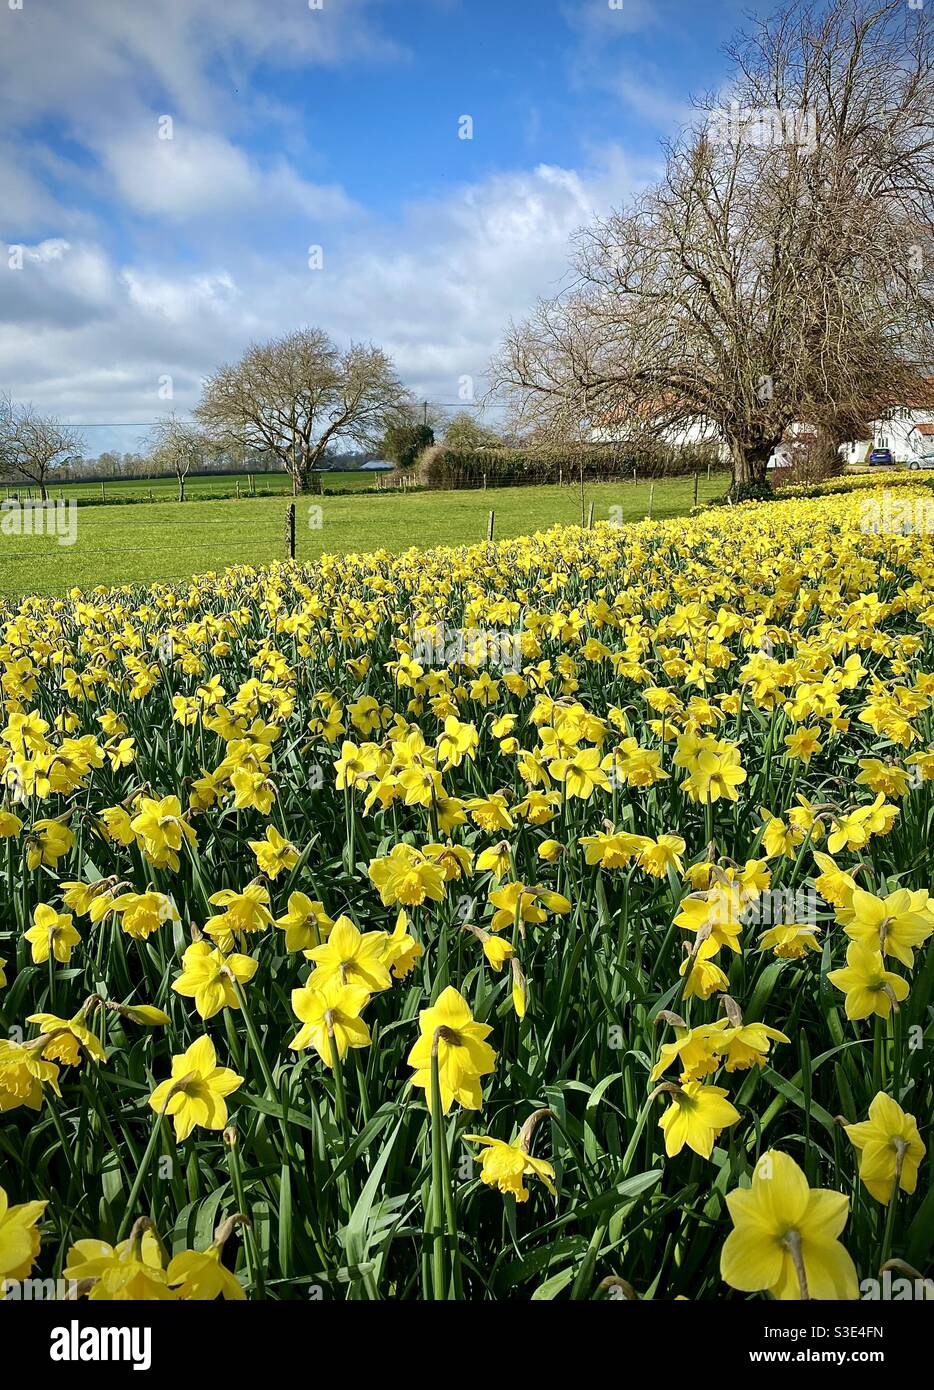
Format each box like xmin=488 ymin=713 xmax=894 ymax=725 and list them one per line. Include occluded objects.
xmin=0 ymin=150 xmax=638 ymax=452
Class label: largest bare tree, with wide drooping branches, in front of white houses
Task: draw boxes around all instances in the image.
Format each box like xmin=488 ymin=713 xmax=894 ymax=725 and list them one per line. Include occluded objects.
xmin=492 ymin=0 xmax=934 ymax=484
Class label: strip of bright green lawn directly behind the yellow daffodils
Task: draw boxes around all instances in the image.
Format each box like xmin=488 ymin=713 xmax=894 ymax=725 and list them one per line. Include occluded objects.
xmin=0 ymin=474 xmax=728 ymax=596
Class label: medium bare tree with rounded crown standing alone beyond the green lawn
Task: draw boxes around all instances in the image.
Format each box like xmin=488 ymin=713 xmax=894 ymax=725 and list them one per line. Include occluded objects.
xmin=196 ymin=328 xmax=413 ymax=492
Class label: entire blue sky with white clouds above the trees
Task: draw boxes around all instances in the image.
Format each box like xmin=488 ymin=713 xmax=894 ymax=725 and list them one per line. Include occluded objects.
xmin=0 ymin=0 xmax=770 ymax=453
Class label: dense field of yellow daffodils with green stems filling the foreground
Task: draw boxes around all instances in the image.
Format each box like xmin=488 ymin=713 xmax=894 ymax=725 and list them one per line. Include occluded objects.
xmin=0 ymin=487 xmax=934 ymax=1300
